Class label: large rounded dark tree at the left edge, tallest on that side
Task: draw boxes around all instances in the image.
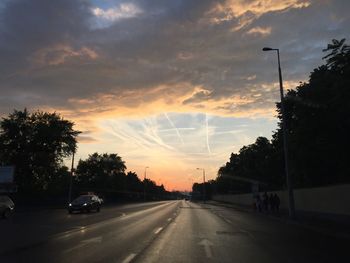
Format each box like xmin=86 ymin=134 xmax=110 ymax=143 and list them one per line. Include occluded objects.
xmin=0 ymin=109 xmax=80 ymax=194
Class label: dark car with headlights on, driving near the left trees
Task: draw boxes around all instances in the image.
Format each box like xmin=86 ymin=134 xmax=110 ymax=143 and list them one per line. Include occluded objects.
xmin=68 ymin=195 xmax=101 ymax=214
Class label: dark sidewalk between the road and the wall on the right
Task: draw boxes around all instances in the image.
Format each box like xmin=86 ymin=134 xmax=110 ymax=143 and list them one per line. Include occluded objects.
xmin=206 ymin=201 xmax=350 ymax=239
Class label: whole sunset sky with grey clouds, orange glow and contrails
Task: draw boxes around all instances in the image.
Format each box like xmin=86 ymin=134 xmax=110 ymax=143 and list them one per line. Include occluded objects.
xmin=0 ymin=0 xmax=350 ymax=190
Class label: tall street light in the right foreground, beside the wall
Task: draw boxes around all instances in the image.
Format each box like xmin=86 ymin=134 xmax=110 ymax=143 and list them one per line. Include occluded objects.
xmin=262 ymin=47 xmax=295 ymax=218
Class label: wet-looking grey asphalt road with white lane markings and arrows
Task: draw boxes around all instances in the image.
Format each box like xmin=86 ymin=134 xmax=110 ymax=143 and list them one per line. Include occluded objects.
xmin=0 ymin=200 xmax=344 ymax=263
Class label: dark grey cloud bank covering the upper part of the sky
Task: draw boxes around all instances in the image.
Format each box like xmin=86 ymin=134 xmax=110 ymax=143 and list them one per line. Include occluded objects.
xmin=0 ymin=0 xmax=350 ymax=117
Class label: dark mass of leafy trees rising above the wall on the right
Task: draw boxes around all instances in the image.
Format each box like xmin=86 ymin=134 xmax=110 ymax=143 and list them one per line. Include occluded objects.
xmin=216 ymin=39 xmax=350 ymax=193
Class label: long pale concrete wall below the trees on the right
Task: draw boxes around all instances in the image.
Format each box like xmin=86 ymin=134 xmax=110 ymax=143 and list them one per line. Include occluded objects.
xmin=213 ymin=184 xmax=350 ymax=215
